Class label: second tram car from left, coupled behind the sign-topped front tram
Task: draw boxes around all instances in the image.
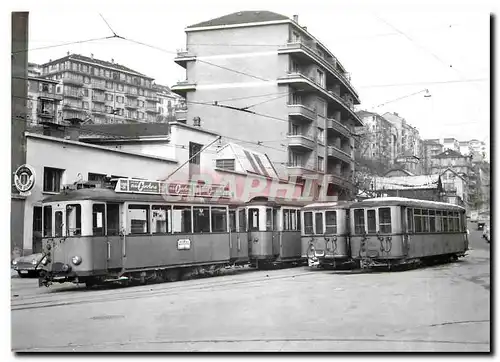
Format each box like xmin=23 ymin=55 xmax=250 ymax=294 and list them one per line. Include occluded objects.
xmin=245 ymin=197 xmax=305 ymax=268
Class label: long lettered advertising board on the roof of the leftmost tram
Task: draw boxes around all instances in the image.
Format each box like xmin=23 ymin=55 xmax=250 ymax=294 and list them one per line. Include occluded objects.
xmin=115 ymin=179 xmax=231 ymax=198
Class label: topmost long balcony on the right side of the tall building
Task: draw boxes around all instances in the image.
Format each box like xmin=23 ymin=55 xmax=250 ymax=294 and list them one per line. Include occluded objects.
xmin=278 ymin=40 xmax=359 ymax=99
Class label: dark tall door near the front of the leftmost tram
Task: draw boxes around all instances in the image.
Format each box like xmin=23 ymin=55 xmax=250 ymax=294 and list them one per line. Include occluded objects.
xmin=106 ymin=203 xmax=124 ymax=269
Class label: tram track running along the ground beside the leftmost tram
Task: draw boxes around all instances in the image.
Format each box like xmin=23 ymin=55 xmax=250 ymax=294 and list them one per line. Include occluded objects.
xmin=11 ymin=271 xmax=324 ymax=311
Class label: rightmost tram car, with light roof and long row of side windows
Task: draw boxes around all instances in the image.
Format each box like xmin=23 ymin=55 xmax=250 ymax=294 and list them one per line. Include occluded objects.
xmin=349 ymin=197 xmax=468 ymax=269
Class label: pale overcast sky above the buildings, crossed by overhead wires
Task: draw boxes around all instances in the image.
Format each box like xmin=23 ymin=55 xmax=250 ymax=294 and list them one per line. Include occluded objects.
xmin=10 ymin=0 xmax=492 ymax=148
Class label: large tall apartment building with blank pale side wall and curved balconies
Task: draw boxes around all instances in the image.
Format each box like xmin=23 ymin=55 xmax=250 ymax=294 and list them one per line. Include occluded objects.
xmin=172 ymin=11 xmax=362 ymax=198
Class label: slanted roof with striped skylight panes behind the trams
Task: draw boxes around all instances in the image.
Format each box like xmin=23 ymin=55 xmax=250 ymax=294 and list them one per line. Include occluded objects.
xmin=218 ymin=142 xmax=279 ymax=178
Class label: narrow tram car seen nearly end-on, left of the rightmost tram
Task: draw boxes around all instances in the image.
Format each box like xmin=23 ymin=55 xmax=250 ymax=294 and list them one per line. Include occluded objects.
xmin=301 ymin=201 xmax=353 ymax=268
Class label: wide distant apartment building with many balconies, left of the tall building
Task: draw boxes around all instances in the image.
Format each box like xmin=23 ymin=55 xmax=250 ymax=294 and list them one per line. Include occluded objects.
xmin=41 ymin=54 xmax=175 ymax=124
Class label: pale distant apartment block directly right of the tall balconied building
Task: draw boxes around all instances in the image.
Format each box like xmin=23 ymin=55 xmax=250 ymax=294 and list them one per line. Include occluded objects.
xmin=355 ymin=111 xmax=398 ymax=170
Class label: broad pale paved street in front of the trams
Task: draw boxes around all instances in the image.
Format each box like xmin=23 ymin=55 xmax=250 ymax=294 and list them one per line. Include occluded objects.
xmin=11 ymin=226 xmax=490 ymax=352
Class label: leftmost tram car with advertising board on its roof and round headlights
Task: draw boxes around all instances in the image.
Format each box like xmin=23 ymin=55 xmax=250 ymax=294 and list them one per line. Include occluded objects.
xmin=39 ymin=179 xmax=249 ymax=286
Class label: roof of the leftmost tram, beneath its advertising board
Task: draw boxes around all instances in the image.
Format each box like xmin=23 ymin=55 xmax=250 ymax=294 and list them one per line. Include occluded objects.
xmin=43 ymin=188 xmax=243 ymax=206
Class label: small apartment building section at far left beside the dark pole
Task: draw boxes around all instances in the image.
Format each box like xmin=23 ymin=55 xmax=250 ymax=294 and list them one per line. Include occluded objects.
xmin=26 ymin=76 xmax=62 ymax=125
